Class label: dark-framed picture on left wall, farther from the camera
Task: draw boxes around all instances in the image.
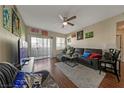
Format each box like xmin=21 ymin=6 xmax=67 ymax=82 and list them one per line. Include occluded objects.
xmin=12 ymin=10 xmax=21 ymax=37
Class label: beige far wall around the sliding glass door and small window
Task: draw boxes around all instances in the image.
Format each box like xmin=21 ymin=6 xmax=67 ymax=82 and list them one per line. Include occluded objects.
xmin=27 ymin=27 xmax=66 ymax=57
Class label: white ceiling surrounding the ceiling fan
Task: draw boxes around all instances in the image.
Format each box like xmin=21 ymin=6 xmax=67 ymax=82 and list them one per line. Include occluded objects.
xmin=17 ymin=5 xmax=124 ymax=34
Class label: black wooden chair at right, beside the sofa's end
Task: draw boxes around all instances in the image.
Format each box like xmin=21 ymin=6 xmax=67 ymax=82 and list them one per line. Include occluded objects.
xmin=99 ymin=49 xmax=120 ymax=82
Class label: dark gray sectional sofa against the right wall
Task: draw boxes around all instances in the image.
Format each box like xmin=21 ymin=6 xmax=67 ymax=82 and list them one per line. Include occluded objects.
xmin=57 ymin=48 xmax=102 ymax=69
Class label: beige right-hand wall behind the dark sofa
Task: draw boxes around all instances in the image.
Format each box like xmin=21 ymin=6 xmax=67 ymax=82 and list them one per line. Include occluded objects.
xmin=68 ymin=13 xmax=124 ymax=49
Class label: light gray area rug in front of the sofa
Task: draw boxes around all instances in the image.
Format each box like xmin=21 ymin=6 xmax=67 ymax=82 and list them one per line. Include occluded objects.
xmin=55 ymin=62 xmax=105 ymax=88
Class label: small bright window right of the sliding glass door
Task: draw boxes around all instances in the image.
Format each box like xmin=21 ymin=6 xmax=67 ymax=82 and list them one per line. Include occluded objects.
xmin=56 ymin=37 xmax=65 ymax=50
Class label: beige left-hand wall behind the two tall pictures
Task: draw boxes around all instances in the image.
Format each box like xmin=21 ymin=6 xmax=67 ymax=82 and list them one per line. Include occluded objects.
xmin=0 ymin=6 xmax=26 ymax=63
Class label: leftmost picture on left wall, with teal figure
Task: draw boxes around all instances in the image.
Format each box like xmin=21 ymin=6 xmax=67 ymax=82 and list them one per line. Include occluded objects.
xmin=2 ymin=5 xmax=12 ymax=32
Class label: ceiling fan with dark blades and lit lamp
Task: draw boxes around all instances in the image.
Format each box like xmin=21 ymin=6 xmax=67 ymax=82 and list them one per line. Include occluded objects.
xmin=59 ymin=15 xmax=76 ymax=27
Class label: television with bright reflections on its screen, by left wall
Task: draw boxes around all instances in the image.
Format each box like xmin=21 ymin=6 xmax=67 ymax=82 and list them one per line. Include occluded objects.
xmin=18 ymin=39 xmax=28 ymax=65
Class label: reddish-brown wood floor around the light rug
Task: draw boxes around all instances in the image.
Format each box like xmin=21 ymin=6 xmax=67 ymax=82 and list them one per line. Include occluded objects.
xmin=34 ymin=58 xmax=124 ymax=88
